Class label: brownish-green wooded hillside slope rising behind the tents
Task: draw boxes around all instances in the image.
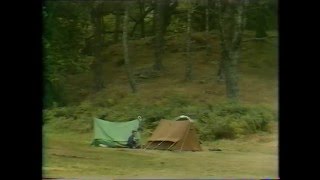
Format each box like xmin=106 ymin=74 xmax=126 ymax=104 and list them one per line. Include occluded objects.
xmin=44 ymin=32 xmax=278 ymax=131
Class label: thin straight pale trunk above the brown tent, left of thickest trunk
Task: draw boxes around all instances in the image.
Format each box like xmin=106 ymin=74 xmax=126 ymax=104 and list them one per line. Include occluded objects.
xmin=185 ymin=0 xmax=193 ymax=81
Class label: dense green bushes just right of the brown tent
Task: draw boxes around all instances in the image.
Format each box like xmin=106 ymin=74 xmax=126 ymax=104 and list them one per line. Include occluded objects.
xmin=199 ymin=103 xmax=275 ymax=140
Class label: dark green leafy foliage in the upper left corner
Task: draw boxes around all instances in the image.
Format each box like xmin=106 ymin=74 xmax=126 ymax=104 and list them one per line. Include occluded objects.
xmin=43 ymin=1 xmax=91 ymax=82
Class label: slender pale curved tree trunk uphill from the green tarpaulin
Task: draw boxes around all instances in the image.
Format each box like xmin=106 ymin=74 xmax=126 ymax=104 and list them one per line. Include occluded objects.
xmin=122 ymin=7 xmax=136 ymax=93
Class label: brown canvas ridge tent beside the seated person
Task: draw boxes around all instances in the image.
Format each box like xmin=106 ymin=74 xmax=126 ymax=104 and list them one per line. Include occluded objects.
xmin=146 ymin=119 xmax=202 ymax=151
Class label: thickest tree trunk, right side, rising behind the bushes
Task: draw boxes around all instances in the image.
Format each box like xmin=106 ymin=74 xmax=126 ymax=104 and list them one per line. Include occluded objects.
xmin=219 ymin=0 xmax=244 ymax=102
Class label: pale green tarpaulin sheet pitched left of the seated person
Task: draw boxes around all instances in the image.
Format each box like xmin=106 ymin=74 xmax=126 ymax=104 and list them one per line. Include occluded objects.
xmin=91 ymin=118 xmax=140 ymax=147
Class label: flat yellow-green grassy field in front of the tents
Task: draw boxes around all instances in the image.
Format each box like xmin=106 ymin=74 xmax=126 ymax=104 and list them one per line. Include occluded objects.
xmin=43 ymin=124 xmax=278 ymax=179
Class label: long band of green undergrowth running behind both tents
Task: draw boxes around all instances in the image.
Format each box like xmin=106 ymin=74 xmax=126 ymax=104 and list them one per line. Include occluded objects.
xmin=44 ymin=99 xmax=276 ymax=141
